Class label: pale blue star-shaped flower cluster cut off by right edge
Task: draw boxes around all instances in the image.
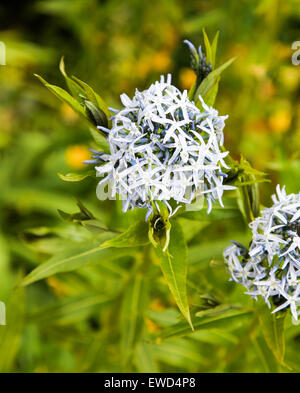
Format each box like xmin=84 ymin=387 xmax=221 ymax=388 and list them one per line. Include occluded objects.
xmin=224 ymin=186 xmax=300 ymax=320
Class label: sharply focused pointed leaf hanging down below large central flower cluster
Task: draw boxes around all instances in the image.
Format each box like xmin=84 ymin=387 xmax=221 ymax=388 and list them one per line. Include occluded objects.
xmin=156 ymin=221 xmax=193 ymax=329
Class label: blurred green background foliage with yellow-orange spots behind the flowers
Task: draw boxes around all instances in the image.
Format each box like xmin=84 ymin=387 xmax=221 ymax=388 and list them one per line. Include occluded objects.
xmin=0 ymin=0 xmax=300 ymax=372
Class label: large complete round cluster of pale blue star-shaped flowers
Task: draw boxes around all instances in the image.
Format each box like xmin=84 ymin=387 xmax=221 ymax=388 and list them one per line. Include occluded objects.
xmin=89 ymin=75 xmax=235 ymax=219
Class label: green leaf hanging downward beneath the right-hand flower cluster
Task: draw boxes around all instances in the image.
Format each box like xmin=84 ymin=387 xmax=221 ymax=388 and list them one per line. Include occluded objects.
xmin=258 ymin=304 xmax=286 ymax=365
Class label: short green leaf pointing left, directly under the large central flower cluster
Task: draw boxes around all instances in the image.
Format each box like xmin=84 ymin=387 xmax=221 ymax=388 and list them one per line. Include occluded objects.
xmin=101 ymin=220 xmax=150 ymax=248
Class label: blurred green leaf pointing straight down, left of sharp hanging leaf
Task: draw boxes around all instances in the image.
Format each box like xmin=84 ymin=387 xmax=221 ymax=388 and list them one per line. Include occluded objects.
xmin=120 ymin=273 xmax=148 ymax=370
